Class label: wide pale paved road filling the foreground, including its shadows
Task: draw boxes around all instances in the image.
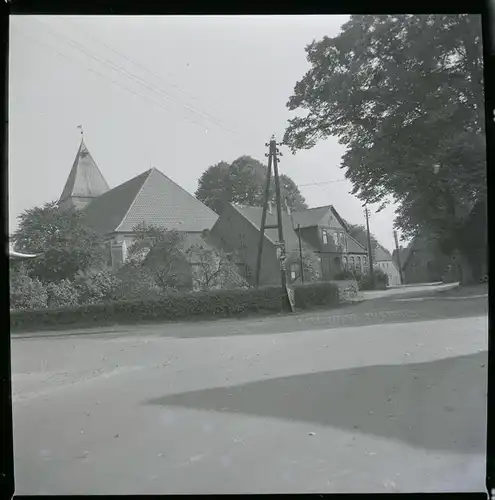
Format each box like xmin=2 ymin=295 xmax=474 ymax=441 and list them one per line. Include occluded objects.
xmin=12 ymin=296 xmax=488 ymax=494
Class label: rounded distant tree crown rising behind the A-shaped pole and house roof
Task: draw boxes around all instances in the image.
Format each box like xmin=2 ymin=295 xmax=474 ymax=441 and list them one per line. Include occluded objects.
xmin=195 ymin=156 xmax=307 ymax=214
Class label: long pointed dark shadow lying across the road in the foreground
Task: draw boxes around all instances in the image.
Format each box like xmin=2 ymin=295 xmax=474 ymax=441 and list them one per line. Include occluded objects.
xmin=147 ymin=352 xmax=487 ymax=453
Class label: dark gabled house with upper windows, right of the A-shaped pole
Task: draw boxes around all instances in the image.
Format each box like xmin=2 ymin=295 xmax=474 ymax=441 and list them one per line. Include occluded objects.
xmin=292 ymin=205 xmax=368 ymax=280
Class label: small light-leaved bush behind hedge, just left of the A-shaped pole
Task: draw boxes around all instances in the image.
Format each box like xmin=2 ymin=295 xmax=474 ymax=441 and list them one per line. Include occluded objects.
xmin=186 ymin=244 xmax=247 ymax=291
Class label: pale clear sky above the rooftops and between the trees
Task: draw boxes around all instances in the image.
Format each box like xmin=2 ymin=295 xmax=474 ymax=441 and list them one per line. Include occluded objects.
xmin=9 ymin=15 xmax=404 ymax=250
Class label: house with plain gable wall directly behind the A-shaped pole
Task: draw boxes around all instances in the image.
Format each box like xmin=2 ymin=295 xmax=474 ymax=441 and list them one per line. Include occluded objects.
xmin=210 ymin=203 xmax=318 ymax=286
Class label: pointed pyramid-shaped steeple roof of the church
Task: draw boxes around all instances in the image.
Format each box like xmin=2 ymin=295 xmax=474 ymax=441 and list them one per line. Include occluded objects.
xmin=59 ymin=140 xmax=109 ymax=202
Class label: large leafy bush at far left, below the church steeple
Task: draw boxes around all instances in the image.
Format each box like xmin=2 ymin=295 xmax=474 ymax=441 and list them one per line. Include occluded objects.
xmin=13 ymin=202 xmax=104 ymax=282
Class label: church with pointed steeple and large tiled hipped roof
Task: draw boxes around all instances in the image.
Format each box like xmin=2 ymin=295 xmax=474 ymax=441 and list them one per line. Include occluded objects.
xmin=59 ymin=140 xmax=218 ymax=268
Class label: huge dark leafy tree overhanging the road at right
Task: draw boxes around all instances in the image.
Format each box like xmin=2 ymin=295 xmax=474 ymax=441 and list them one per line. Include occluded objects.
xmin=284 ymin=15 xmax=486 ymax=277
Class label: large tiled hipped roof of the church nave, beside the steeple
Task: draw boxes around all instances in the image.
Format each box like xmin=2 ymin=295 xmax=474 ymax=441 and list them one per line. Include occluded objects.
xmin=84 ymin=168 xmax=218 ymax=234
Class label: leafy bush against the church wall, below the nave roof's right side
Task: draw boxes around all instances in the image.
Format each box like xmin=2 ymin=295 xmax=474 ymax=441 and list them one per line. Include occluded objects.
xmin=126 ymin=223 xmax=192 ymax=293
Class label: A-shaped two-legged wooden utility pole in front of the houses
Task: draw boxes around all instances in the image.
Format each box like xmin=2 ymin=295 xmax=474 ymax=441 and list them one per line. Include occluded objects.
xmin=256 ymin=135 xmax=287 ymax=294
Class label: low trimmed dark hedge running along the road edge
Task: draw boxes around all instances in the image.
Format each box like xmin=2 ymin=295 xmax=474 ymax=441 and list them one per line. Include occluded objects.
xmin=10 ymin=283 xmax=339 ymax=332
